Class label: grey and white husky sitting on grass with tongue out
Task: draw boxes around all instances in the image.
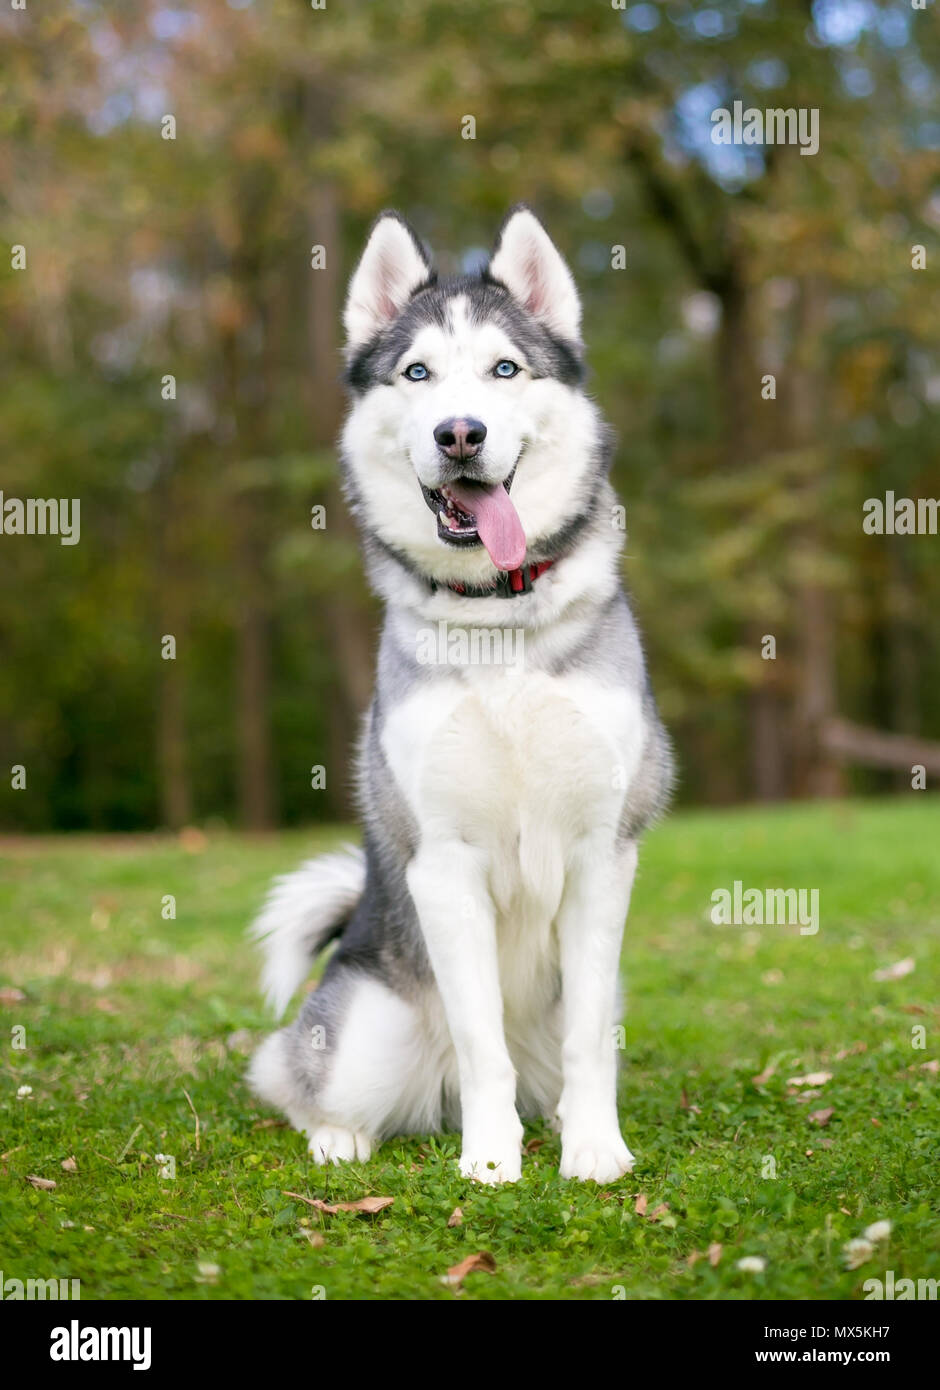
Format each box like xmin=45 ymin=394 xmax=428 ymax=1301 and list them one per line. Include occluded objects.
xmin=250 ymin=207 xmax=672 ymax=1183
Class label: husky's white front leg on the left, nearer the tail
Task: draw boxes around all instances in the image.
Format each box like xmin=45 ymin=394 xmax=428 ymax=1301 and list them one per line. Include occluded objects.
xmin=407 ymin=840 xmax=523 ymax=1183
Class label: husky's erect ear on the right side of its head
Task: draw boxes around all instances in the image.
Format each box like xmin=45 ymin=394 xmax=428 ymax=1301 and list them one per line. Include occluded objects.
xmin=489 ymin=204 xmax=581 ymax=343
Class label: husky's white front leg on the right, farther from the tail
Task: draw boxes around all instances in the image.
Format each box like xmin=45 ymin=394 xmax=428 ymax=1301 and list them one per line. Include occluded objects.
xmin=558 ymin=837 xmax=637 ymax=1183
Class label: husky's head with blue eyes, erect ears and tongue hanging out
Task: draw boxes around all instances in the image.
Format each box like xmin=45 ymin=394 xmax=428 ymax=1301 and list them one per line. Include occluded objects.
xmin=343 ymin=207 xmax=601 ymax=584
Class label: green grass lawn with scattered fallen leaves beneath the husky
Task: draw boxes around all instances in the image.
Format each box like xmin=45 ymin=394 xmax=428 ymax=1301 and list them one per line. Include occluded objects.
xmin=0 ymin=795 xmax=940 ymax=1300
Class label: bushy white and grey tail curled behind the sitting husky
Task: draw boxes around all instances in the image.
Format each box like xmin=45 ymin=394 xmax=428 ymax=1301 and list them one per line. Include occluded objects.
xmin=250 ymin=845 xmax=366 ymax=1017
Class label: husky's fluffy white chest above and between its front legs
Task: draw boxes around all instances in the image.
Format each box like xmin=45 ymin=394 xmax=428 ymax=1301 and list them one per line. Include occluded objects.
xmin=382 ymin=667 xmax=642 ymax=931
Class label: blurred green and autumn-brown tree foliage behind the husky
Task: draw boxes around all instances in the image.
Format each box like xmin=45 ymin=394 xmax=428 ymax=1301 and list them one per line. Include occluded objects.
xmin=0 ymin=0 xmax=940 ymax=828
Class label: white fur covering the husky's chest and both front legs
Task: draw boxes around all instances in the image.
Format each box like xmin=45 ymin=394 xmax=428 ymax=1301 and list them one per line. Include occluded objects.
xmin=382 ymin=644 xmax=644 ymax=1182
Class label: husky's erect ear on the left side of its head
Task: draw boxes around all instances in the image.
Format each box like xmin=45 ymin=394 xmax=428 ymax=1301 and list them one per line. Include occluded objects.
xmin=343 ymin=213 xmax=431 ymax=348
